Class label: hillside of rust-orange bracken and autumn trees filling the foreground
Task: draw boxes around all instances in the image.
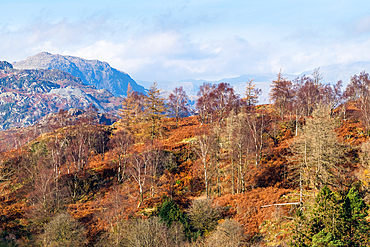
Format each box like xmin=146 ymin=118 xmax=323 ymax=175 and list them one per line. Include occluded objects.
xmin=0 ymin=69 xmax=370 ymax=247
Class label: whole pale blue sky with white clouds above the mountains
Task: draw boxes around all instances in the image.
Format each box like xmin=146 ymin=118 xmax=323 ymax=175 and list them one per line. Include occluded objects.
xmin=0 ymin=0 xmax=370 ymax=81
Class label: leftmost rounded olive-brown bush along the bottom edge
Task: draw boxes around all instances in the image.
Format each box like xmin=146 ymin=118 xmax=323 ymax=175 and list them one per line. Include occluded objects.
xmin=40 ymin=213 xmax=87 ymax=247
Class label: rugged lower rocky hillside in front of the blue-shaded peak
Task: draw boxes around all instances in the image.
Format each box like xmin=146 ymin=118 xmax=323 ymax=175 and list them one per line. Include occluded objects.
xmin=0 ymin=61 xmax=122 ymax=129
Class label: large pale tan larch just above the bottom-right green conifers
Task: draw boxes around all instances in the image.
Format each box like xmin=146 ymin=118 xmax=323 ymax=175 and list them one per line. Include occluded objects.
xmin=291 ymin=105 xmax=343 ymax=194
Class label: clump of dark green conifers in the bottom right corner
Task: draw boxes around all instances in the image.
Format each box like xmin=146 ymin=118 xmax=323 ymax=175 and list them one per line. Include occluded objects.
xmin=291 ymin=186 xmax=370 ymax=247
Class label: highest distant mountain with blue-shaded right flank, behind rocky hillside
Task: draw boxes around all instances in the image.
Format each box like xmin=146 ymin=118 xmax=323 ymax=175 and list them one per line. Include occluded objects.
xmin=13 ymin=52 xmax=145 ymax=96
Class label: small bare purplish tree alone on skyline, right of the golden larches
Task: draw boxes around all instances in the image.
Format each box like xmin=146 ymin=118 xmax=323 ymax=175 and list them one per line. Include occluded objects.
xmin=168 ymin=87 xmax=189 ymax=128
